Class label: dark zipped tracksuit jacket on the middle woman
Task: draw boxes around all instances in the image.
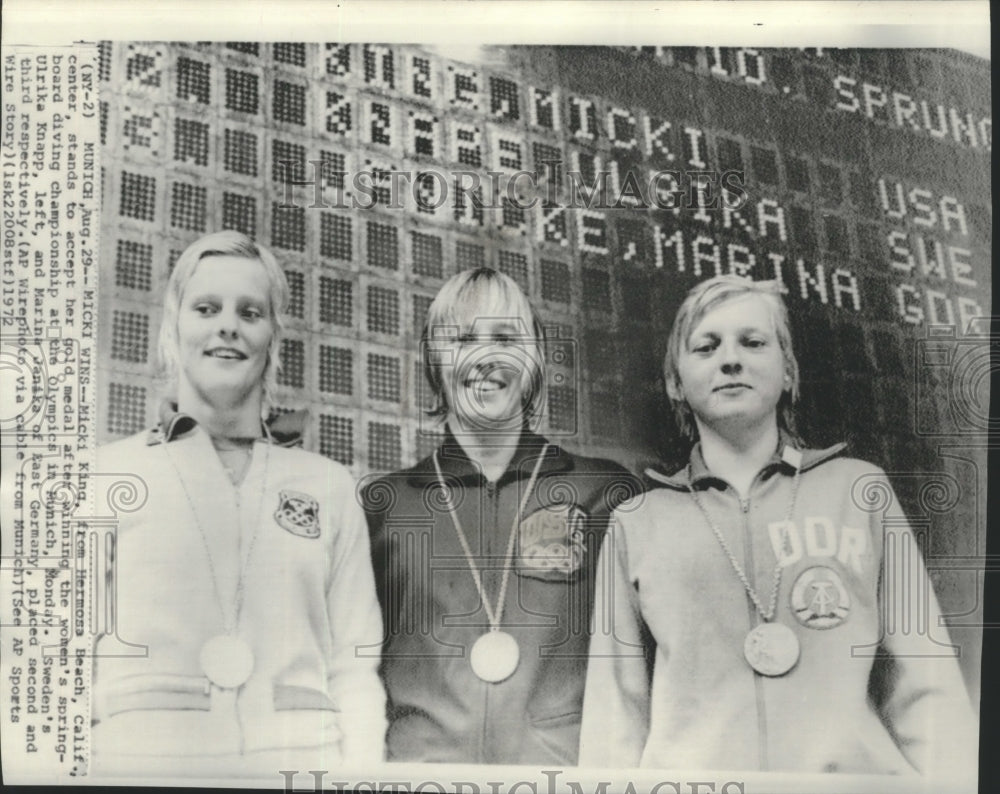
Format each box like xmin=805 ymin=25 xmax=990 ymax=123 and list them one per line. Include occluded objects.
xmin=363 ymin=430 xmax=641 ymax=764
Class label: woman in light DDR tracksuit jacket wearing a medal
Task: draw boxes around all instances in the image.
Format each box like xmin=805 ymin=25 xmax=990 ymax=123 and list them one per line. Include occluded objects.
xmin=580 ymin=276 xmax=977 ymax=789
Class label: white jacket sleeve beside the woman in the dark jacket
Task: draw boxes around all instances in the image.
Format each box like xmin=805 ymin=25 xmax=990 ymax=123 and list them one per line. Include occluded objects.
xmin=327 ymin=470 xmax=386 ymax=762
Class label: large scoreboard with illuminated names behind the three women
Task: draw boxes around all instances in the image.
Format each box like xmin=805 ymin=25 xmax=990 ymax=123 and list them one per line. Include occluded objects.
xmin=99 ymin=42 xmax=992 ymax=482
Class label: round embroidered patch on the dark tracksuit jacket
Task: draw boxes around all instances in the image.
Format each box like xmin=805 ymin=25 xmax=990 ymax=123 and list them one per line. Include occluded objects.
xmin=517 ymin=504 xmax=587 ymax=576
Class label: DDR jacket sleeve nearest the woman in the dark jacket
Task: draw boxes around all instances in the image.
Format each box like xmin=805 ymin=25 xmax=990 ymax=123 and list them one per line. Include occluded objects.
xmin=580 ymin=514 xmax=653 ymax=767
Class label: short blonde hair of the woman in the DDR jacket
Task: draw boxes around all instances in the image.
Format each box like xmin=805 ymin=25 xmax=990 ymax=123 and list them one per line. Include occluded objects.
xmin=663 ymin=276 xmax=799 ymax=440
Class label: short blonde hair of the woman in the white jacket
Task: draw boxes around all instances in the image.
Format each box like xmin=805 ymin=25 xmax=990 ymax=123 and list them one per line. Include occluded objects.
xmin=159 ymin=231 xmax=288 ymax=406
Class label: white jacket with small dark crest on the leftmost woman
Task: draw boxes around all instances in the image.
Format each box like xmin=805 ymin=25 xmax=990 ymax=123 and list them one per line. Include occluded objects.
xmin=93 ymin=419 xmax=385 ymax=769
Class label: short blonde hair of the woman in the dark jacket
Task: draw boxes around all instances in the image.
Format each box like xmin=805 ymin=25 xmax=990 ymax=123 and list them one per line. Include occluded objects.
xmin=421 ymin=267 xmax=545 ymax=418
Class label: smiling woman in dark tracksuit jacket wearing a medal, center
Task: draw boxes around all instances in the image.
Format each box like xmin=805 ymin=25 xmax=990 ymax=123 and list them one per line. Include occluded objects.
xmin=363 ymin=268 xmax=639 ymax=764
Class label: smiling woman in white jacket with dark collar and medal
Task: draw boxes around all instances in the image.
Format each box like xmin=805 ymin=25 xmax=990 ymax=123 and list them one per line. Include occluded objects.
xmin=92 ymin=232 xmax=385 ymax=777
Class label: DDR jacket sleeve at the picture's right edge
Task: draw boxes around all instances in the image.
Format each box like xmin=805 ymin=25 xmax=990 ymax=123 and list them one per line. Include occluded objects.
xmin=872 ymin=471 xmax=979 ymax=789
